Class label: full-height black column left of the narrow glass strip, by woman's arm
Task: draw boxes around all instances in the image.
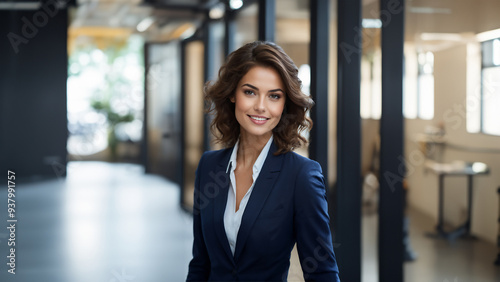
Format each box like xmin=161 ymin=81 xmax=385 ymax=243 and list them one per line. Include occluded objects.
xmin=334 ymin=0 xmax=362 ymax=281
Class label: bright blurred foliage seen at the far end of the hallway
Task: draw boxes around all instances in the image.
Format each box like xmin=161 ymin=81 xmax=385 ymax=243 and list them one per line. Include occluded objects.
xmin=68 ymin=34 xmax=144 ymax=160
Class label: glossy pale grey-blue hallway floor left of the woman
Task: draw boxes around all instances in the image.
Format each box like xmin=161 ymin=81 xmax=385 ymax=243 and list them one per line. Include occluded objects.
xmin=0 ymin=162 xmax=192 ymax=282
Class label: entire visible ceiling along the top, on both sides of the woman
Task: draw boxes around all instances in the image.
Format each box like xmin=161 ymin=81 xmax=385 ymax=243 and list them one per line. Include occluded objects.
xmin=70 ymin=0 xmax=500 ymax=47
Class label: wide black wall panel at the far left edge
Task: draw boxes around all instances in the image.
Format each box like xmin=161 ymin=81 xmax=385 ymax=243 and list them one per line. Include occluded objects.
xmin=0 ymin=5 xmax=68 ymax=179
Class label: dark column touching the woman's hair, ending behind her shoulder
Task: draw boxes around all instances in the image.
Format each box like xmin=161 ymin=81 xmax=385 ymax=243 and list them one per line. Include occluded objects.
xmin=309 ymin=0 xmax=330 ymax=183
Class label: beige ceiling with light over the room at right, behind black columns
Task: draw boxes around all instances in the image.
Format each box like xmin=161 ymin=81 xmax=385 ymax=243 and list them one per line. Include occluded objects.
xmin=363 ymin=0 xmax=500 ymax=51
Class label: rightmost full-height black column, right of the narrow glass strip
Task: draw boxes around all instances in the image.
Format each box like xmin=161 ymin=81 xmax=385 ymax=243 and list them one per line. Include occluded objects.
xmin=378 ymin=0 xmax=405 ymax=281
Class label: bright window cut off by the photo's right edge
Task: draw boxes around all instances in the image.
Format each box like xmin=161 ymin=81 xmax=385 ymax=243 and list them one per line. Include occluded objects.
xmin=480 ymin=38 xmax=500 ymax=136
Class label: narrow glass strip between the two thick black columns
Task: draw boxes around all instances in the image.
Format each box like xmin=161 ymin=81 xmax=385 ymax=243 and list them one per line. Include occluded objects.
xmin=360 ymin=0 xmax=382 ymax=282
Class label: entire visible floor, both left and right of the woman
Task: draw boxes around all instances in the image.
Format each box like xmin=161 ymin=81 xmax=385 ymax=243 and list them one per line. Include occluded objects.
xmin=0 ymin=162 xmax=500 ymax=282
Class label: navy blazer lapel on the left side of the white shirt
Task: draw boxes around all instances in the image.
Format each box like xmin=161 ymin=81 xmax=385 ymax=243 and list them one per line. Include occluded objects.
xmin=210 ymin=150 xmax=234 ymax=264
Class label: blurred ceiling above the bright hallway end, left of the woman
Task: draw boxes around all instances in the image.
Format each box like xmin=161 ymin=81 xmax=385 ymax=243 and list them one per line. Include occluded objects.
xmin=70 ymin=0 xmax=223 ymax=41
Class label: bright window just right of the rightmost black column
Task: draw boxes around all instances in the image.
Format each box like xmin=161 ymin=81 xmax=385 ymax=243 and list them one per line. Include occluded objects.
xmin=404 ymin=52 xmax=434 ymax=120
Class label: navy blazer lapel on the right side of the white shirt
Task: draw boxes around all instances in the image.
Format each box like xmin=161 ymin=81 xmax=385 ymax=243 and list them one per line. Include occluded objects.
xmin=234 ymin=142 xmax=283 ymax=261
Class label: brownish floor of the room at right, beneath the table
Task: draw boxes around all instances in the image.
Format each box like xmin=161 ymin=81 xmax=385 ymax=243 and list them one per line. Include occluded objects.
xmin=362 ymin=205 xmax=500 ymax=282
